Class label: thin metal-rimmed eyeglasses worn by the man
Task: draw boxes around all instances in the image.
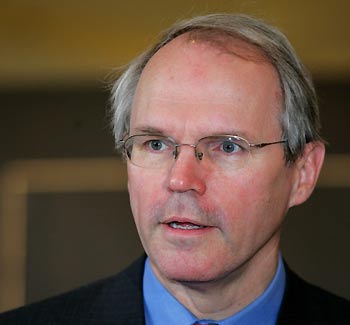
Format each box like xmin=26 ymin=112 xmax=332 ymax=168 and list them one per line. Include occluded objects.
xmin=120 ymin=134 xmax=287 ymax=169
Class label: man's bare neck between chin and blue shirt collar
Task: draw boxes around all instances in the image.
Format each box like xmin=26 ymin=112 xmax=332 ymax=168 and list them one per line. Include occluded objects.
xmin=152 ymin=237 xmax=278 ymax=320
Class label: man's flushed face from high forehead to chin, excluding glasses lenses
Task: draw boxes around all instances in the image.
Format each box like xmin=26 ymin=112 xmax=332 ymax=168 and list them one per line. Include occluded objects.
xmin=128 ymin=35 xmax=295 ymax=282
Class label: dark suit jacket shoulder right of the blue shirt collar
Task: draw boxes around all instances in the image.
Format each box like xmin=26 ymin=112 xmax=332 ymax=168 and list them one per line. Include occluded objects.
xmin=278 ymin=267 xmax=350 ymax=325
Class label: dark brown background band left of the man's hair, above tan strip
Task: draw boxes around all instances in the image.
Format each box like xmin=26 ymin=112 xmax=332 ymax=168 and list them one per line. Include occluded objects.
xmin=0 ymin=88 xmax=114 ymax=162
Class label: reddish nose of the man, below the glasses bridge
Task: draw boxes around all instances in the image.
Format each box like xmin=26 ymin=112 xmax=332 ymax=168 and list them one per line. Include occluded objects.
xmin=168 ymin=146 xmax=206 ymax=195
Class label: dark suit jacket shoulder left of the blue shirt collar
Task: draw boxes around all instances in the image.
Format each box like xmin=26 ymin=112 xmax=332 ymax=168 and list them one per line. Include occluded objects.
xmin=0 ymin=257 xmax=145 ymax=324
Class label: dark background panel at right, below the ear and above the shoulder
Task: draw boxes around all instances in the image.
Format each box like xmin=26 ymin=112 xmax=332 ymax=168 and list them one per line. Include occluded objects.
xmin=282 ymin=188 xmax=350 ymax=299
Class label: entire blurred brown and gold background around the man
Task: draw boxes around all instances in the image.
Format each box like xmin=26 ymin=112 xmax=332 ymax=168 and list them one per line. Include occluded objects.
xmin=0 ymin=0 xmax=350 ymax=311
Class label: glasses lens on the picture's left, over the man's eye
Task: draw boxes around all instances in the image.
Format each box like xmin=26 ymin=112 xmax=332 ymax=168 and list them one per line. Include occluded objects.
xmin=125 ymin=135 xmax=175 ymax=168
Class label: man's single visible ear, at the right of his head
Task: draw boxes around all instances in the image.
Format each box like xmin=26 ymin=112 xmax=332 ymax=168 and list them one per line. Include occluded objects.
xmin=289 ymin=141 xmax=325 ymax=207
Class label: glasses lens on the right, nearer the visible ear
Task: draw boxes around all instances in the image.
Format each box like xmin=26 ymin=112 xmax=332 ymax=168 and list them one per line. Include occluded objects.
xmin=197 ymin=136 xmax=250 ymax=169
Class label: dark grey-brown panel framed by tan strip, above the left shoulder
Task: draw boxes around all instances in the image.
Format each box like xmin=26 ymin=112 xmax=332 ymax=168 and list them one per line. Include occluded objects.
xmin=26 ymin=191 xmax=143 ymax=302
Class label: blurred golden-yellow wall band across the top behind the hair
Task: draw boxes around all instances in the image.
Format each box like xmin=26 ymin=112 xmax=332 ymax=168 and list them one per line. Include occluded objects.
xmin=0 ymin=0 xmax=350 ymax=87
